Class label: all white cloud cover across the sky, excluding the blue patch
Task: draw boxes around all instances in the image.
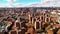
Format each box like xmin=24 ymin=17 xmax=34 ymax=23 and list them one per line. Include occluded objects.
xmin=0 ymin=0 xmax=60 ymax=7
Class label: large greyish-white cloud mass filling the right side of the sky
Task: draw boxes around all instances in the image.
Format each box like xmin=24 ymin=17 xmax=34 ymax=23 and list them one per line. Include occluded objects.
xmin=28 ymin=0 xmax=60 ymax=7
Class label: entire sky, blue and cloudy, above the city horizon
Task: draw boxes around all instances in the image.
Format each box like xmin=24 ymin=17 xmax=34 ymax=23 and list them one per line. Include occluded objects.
xmin=0 ymin=0 xmax=60 ymax=7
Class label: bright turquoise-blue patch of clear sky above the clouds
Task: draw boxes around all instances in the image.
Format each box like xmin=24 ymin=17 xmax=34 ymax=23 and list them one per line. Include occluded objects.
xmin=0 ymin=0 xmax=40 ymax=4
